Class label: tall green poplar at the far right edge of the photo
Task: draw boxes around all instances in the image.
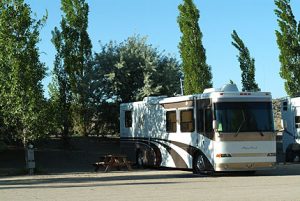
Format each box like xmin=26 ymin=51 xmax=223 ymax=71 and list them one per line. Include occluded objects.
xmin=275 ymin=0 xmax=300 ymax=96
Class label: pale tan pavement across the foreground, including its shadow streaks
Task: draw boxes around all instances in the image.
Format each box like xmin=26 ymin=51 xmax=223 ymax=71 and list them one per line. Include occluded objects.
xmin=0 ymin=164 xmax=300 ymax=201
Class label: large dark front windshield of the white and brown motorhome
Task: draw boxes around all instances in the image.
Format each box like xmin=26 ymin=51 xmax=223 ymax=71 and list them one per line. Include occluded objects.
xmin=215 ymin=102 xmax=274 ymax=133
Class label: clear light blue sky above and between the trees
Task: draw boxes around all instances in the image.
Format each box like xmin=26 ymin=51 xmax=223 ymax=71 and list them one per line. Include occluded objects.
xmin=25 ymin=0 xmax=300 ymax=98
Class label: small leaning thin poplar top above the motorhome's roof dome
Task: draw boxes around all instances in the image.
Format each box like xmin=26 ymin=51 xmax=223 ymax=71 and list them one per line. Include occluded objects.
xmin=231 ymin=30 xmax=260 ymax=91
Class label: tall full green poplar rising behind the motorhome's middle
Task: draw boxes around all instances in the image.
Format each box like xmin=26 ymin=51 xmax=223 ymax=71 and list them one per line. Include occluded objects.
xmin=177 ymin=0 xmax=212 ymax=94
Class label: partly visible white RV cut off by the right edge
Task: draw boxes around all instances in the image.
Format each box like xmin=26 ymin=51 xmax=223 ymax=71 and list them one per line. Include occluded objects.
xmin=281 ymin=97 xmax=300 ymax=162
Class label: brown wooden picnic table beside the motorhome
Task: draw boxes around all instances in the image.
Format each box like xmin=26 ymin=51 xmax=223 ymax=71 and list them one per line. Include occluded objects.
xmin=93 ymin=154 xmax=132 ymax=172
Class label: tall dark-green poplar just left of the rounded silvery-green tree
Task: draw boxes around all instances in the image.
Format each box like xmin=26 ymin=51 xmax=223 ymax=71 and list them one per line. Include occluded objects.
xmin=52 ymin=0 xmax=93 ymax=137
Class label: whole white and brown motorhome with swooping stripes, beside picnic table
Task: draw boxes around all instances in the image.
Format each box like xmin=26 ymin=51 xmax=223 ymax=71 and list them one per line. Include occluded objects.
xmin=120 ymin=84 xmax=276 ymax=173
